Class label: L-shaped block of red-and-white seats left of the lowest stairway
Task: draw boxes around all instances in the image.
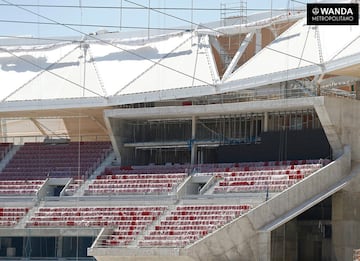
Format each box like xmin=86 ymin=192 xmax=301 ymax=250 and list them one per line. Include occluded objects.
xmin=26 ymin=206 xmax=167 ymax=246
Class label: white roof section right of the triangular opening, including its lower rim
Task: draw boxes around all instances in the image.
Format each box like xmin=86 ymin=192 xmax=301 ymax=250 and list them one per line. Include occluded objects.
xmin=222 ymin=18 xmax=360 ymax=91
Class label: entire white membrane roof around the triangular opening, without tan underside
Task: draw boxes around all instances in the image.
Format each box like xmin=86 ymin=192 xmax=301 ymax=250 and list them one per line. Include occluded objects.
xmin=0 ymin=13 xmax=360 ymax=109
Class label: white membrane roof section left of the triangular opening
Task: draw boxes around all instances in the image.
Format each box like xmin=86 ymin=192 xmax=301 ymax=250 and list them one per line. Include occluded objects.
xmin=0 ymin=32 xmax=215 ymax=101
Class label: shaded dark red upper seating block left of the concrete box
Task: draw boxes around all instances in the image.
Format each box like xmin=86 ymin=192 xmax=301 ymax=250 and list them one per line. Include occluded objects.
xmin=0 ymin=142 xmax=111 ymax=180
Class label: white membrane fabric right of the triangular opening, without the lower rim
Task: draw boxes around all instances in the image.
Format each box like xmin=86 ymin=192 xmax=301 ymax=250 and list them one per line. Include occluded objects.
xmin=225 ymin=18 xmax=360 ymax=87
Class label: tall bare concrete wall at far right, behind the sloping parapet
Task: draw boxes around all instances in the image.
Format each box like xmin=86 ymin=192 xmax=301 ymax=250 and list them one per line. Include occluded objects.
xmin=324 ymin=97 xmax=360 ymax=260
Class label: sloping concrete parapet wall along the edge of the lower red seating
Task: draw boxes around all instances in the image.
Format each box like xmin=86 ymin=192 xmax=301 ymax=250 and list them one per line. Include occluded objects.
xmin=88 ymin=147 xmax=352 ymax=261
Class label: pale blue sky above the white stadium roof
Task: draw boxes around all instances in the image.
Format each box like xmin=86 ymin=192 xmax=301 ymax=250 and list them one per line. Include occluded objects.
xmin=0 ymin=0 xmax=305 ymax=38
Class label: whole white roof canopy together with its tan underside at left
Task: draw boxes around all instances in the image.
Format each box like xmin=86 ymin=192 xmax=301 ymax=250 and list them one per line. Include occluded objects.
xmin=0 ymin=8 xmax=360 ymax=136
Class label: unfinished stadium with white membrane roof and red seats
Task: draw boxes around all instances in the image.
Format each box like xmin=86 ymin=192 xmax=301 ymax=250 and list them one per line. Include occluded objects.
xmin=0 ymin=1 xmax=360 ymax=261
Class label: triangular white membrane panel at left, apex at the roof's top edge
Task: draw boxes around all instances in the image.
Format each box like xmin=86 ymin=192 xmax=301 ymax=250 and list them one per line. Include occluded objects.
xmin=6 ymin=44 xmax=104 ymax=101
